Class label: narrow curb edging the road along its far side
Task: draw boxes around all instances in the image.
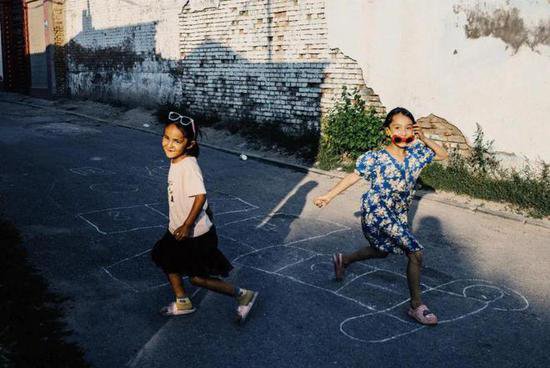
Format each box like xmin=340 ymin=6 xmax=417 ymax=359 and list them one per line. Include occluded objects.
xmin=0 ymin=99 xmax=550 ymax=230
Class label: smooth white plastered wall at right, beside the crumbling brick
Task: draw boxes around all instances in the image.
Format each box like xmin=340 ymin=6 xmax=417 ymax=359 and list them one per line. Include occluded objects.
xmin=326 ymin=0 xmax=550 ymax=162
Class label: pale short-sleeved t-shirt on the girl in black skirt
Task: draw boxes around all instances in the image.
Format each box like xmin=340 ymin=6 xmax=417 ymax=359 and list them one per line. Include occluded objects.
xmin=168 ymin=157 xmax=212 ymax=238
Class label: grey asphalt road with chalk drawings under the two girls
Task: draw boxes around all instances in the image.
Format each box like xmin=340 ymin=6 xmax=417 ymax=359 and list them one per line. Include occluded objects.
xmin=0 ymin=98 xmax=550 ymax=368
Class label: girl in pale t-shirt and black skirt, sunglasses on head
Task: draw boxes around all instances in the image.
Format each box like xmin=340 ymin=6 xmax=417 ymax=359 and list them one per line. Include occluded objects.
xmin=151 ymin=112 xmax=258 ymax=322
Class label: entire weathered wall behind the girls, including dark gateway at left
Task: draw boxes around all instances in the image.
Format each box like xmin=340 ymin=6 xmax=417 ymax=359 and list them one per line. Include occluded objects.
xmin=0 ymin=0 xmax=550 ymax=161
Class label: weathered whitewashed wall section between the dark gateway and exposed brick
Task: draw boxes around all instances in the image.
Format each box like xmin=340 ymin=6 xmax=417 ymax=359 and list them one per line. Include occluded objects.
xmin=65 ymin=0 xmax=182 ymax=106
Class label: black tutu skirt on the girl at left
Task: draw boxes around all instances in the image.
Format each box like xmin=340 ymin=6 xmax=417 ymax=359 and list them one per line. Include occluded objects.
xmin=151 ymin=226 xmax=233 ymax=277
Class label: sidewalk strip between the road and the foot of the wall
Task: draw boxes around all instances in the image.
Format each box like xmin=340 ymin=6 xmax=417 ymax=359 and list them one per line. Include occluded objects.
xmin=0 ymin=92 xmax=550 ymax=229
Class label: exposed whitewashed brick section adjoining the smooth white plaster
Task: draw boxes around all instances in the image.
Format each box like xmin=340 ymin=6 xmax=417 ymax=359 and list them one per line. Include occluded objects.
xmin=179 ymin=0 xmax=384 ymax=127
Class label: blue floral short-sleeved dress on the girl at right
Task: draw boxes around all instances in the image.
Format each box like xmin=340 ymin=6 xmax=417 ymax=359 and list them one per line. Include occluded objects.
xmin=355 ymin=141 xmax=435 ymax=254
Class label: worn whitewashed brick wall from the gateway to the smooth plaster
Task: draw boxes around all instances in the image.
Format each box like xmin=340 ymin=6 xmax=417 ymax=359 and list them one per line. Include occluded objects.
xmin=66 ymin=0 xmax=384 ymax=126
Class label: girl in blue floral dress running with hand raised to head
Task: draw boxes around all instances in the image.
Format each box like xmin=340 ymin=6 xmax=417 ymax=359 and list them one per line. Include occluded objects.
xmin=314 ymin=107 xmax=448 ymax=325
